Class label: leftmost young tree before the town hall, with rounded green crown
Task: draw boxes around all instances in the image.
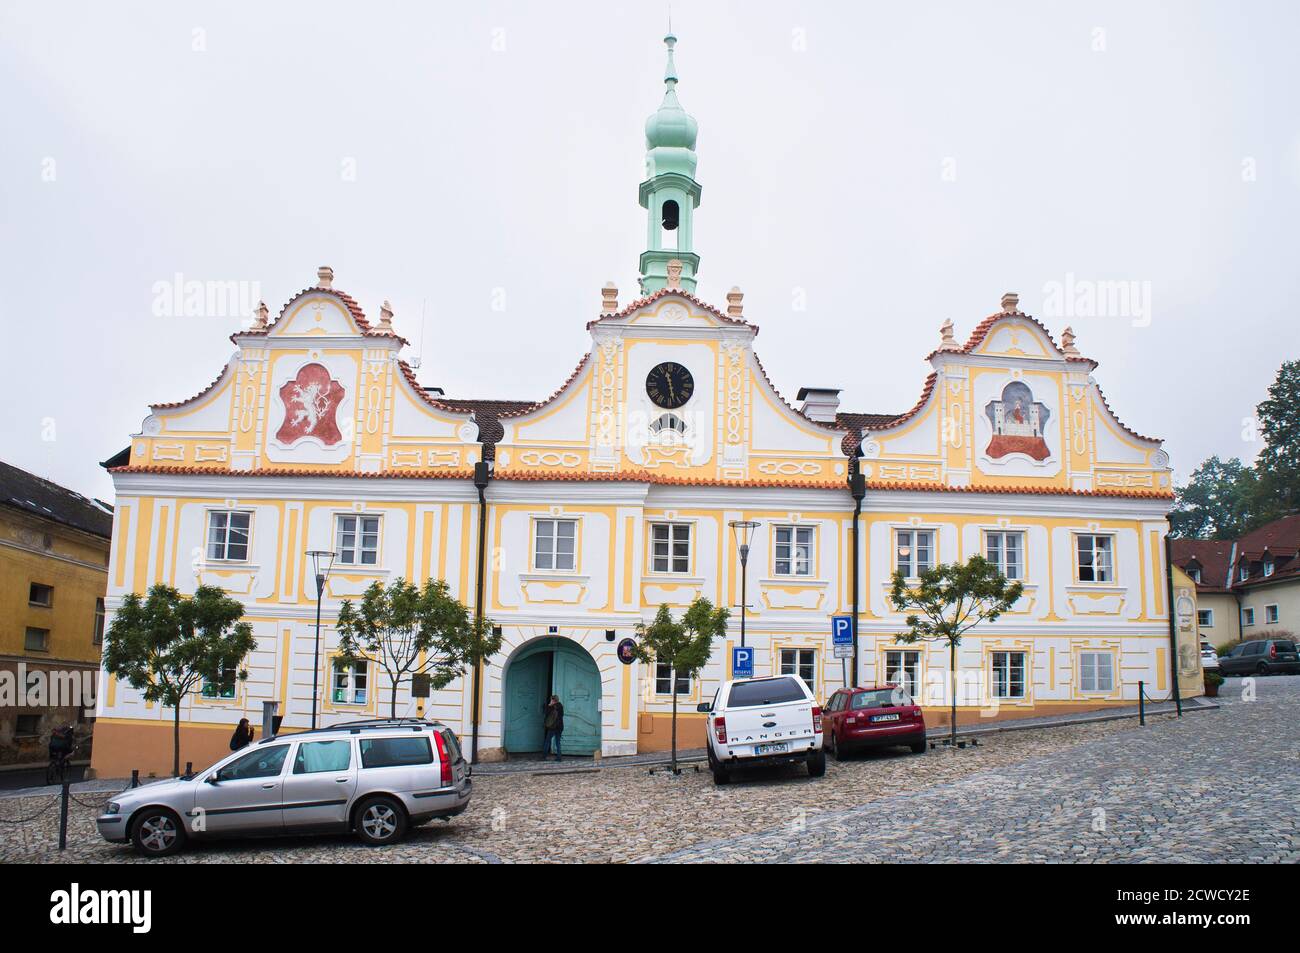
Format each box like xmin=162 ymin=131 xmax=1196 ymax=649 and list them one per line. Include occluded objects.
xmin=104 ymin=584 xmax=257 ymax=776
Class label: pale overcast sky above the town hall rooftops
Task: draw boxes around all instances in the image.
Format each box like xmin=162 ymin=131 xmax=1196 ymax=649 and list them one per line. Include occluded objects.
xmin=0 ymin=0 xmax=1300 ymax=499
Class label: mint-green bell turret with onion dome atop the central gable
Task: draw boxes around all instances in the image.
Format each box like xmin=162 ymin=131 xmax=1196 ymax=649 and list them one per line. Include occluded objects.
xmin=640 ymin=33 xmax=699 ymax=295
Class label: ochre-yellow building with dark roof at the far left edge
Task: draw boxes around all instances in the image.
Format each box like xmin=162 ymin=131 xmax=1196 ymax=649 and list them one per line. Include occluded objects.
xmin=0 ymin=463 xmax=113 ymax=764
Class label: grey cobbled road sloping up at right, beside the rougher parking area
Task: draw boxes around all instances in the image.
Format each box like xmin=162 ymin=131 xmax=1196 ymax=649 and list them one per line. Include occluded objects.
xmin=655 ymin=676 xmax=1300 ymax=863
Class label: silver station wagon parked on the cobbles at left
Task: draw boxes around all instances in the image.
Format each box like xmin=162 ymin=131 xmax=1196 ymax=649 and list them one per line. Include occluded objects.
xmin=96 ymin=719 xmax=472 ymax=857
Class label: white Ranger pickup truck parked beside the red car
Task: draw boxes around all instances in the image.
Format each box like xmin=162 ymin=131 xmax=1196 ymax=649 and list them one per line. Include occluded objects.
xmin=698 ymin=675 xmax=826 ymax=784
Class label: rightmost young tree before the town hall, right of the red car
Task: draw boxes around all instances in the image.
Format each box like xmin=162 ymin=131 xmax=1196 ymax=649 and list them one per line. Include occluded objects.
xmin=887 ymin=555 xmax=1024 ymax=745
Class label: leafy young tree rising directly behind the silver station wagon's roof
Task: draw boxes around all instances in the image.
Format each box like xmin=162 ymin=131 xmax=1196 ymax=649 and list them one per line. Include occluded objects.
xmin=337 ymin=576 xmax=502 ymax=718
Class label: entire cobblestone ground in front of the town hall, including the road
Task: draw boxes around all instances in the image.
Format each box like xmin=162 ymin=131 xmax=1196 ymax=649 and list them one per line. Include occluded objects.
xmin=0 ymin=677 xmax=1300 ymax=863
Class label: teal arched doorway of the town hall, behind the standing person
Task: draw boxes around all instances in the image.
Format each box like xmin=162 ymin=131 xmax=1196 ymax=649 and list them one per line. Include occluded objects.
xmin=502 ymin=636 xmax=601 ymax=754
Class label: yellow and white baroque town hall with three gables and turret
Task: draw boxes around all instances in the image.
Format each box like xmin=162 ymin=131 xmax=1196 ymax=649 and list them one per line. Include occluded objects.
xmin=95 ymin=36 xmax=1173 ymax=775
